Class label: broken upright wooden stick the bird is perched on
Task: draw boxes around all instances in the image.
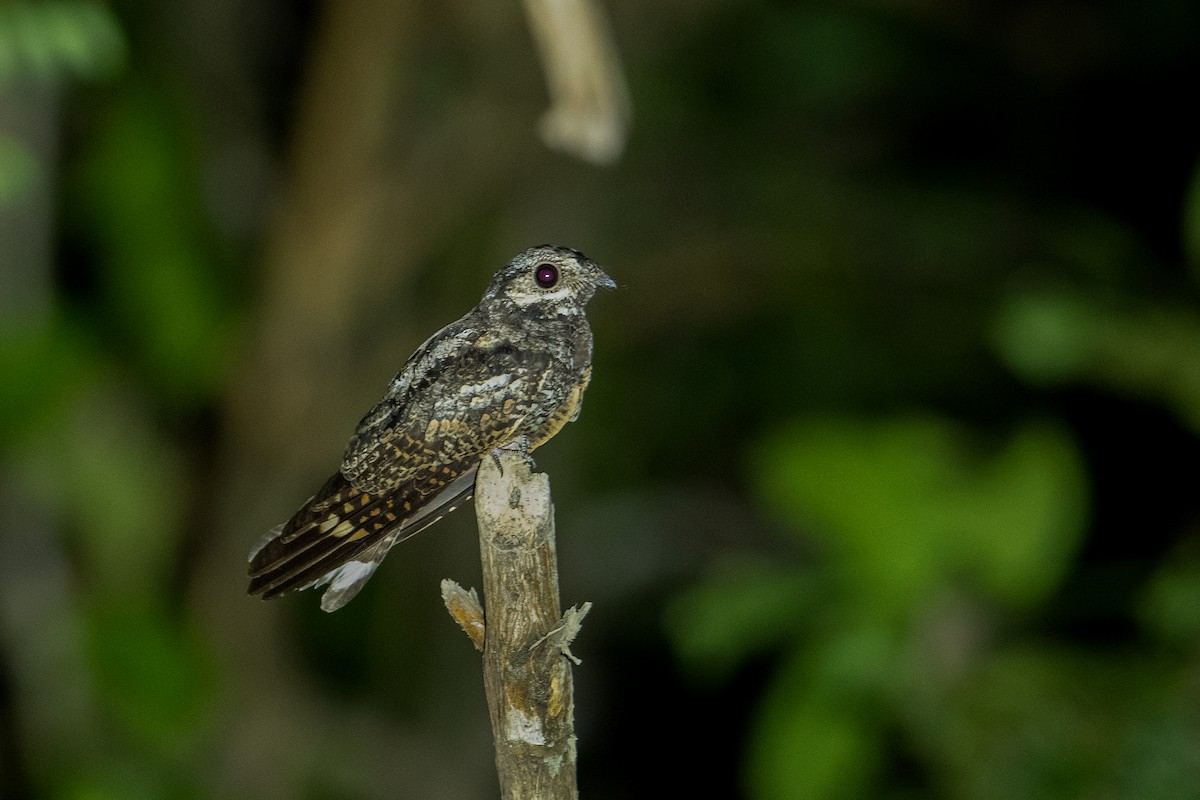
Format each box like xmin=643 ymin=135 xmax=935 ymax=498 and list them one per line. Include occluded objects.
xmin=442 ymin=451 xmax=592 ymax=800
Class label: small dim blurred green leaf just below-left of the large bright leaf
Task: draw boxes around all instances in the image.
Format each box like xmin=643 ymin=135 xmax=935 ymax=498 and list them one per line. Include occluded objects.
xmin=665 ymin=560 xmax=820 ymax=682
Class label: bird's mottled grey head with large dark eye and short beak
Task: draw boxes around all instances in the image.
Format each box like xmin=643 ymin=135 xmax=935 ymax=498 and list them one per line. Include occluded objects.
xmin=484 ymin=245 xmax=617 ymax=315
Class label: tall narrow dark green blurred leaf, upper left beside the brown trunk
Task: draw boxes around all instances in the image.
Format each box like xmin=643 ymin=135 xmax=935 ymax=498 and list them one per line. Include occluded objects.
xmin=69 ymin=85 xmax=236 ymax=401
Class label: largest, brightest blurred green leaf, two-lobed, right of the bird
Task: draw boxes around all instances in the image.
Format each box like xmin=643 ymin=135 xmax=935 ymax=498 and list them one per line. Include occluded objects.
xmin=751 ymin=417 xmax=1086 ymax=614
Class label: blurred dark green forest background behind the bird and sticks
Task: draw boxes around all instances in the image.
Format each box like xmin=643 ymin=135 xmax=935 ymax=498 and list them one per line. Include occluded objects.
xmin=0 ymin=0 xmax=1200 ymax=800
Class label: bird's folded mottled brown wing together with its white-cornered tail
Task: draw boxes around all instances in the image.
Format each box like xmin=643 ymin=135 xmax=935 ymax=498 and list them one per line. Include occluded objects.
xmin=250 ymin=328 xmax=550 ymax=610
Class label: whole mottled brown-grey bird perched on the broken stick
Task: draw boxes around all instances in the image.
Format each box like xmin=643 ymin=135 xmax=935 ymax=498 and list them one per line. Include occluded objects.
xmin=250 ymin=245 xmax=616 ymax=612
